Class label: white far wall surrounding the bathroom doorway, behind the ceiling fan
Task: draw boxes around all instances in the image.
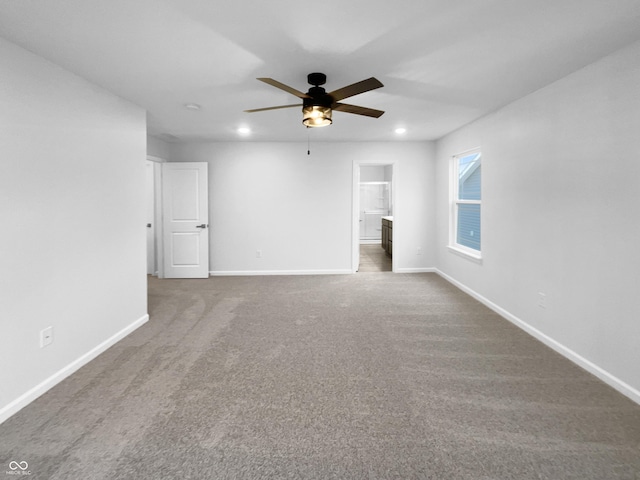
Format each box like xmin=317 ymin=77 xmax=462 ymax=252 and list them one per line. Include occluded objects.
xmin=171 ymin=142 xmax=435 ymax=274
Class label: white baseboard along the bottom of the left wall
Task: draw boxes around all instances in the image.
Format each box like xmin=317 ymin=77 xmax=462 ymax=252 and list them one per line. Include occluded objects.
xmin=0 ymin=314 xmax=149 ymax=423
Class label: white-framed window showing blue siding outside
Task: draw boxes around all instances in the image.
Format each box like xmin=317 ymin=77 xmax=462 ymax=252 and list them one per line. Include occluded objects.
xmin=450 ymin=150 xmax=482 ymax=258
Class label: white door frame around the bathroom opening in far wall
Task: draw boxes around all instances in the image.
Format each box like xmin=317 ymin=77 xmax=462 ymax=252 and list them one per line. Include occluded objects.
xmin=351 ymin=160 xmax=401 ymax=273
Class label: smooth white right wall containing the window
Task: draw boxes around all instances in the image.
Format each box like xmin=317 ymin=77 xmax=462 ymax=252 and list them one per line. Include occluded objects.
xmin=437 ymin=43 xmax=640 ymax=394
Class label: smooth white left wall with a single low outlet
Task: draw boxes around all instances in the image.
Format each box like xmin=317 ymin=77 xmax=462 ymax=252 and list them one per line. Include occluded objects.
xmin=0 ymin=39 xmax=147 ymax=421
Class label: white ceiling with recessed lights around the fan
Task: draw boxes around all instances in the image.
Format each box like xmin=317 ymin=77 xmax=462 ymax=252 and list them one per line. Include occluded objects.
xmin=0 ymin=0 xmax=640 ymax=141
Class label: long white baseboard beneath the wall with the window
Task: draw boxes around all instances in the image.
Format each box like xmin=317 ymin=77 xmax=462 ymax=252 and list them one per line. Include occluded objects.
xmin=434 ymin=269 xmax=640 ymax=404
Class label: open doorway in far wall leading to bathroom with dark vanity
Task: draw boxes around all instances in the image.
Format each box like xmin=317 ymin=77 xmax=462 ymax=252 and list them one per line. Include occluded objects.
xmin=352 ymin=161 xmax=396 ymax=273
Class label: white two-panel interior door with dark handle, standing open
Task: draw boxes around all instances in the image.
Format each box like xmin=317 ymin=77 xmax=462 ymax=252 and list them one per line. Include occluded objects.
xmin=162 ymin=162 xmax=209 ymax=278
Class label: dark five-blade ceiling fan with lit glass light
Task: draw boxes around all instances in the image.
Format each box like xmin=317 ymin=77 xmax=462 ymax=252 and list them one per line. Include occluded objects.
xmin=245 ymin=73 xmax=384 ymax=127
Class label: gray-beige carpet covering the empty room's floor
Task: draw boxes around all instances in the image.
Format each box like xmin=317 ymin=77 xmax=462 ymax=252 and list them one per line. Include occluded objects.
xmin=0 ymin=273 xmax=640 ymax=480
